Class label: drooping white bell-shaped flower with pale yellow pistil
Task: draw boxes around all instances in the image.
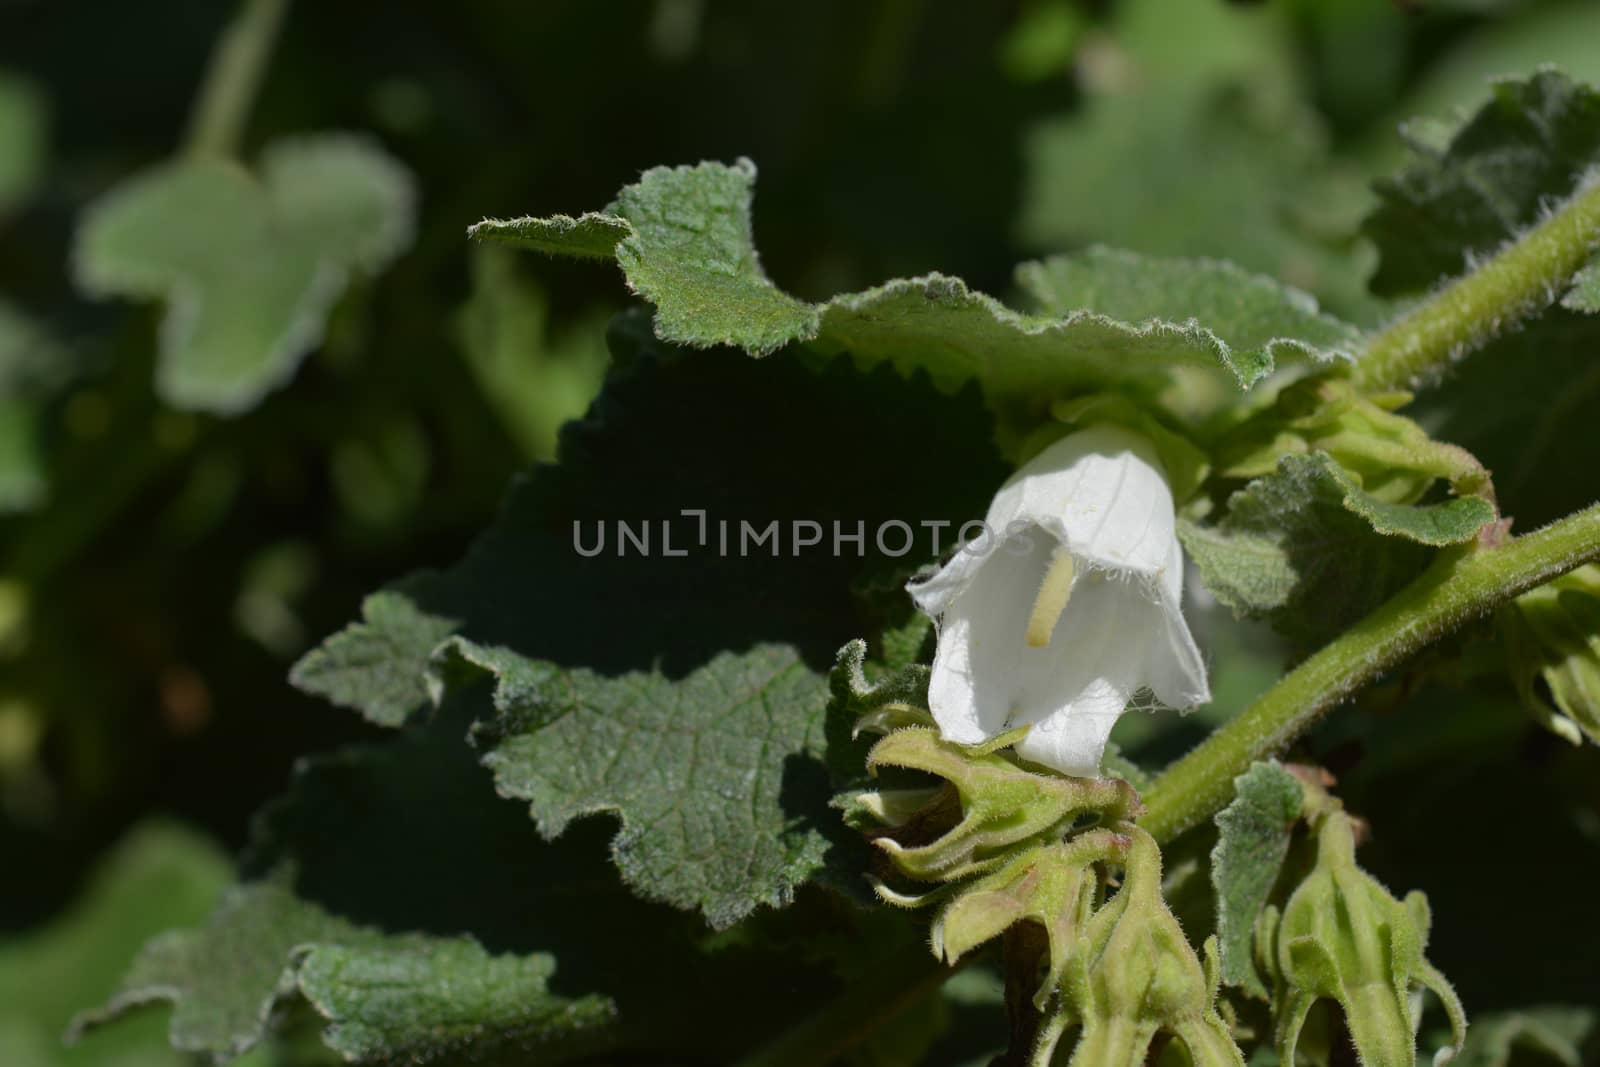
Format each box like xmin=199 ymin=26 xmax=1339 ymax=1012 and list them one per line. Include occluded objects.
xmin=907 ymin=426 xmax=1211 ymax=776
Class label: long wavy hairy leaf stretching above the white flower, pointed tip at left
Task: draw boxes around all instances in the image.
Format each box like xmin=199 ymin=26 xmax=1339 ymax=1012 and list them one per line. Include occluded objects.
xmin=470 ymin=160 xmax=1354 ymax=397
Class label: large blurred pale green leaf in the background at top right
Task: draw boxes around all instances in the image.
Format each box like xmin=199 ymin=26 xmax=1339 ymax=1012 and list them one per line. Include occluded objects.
xmin=1016 ymin=0 xmax=1374 ymax=320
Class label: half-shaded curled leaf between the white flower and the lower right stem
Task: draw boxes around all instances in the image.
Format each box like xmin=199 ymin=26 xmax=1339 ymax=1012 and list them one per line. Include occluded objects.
xmin=1179 ymin=453 xmax=1494 ymax=640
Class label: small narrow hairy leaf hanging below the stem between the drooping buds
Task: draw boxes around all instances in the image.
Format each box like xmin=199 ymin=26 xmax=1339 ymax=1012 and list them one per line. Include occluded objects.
xmin=1211 ymin=761 xmax=1304 ymax=1000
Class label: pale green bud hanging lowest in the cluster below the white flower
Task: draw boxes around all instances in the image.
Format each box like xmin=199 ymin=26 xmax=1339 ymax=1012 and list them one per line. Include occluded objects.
xmin=1035 ymin=827 xmax=1245 ymax=1067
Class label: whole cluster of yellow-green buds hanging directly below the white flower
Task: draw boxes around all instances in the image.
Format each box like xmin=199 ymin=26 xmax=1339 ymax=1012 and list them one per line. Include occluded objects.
xmin=850 ymin=709 xmax=1245 ymax=1067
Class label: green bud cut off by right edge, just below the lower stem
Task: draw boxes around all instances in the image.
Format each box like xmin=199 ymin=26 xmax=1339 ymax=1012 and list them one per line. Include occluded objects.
xmin=1499 ymin=563 xmax=1600 ymax=744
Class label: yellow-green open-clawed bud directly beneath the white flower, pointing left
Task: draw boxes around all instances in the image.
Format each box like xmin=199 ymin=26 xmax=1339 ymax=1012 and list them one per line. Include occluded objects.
xmin=867 ymin=726 xmax=1139 ymax=881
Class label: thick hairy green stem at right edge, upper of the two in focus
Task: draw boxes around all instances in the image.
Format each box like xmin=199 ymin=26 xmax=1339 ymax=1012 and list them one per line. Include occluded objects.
xmin=1352 ymin=179 xmax=1600 ymax=392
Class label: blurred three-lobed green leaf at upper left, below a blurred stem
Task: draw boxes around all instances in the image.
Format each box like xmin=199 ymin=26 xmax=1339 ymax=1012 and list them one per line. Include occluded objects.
xmin=74 ymin=134 xmax=414 ymax=414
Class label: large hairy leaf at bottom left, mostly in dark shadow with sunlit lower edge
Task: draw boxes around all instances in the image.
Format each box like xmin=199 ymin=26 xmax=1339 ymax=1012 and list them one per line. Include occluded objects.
xmin=83 ymin=697 xmax=851 ymax=1067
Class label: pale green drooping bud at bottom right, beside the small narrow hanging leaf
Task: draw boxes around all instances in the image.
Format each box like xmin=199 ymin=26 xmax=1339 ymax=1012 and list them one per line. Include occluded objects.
xmin=1258 ymin=809 xmax=1466 ymax=1067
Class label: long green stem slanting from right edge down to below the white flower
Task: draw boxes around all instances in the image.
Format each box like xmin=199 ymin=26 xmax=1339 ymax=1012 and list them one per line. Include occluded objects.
xmin=1139 ymin=504 xmax=1600 ymax=841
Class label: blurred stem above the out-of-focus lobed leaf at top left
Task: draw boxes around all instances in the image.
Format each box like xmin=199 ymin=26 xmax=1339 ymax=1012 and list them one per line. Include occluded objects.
xmin=184 ymin=0 xmax=288 ymax=155
